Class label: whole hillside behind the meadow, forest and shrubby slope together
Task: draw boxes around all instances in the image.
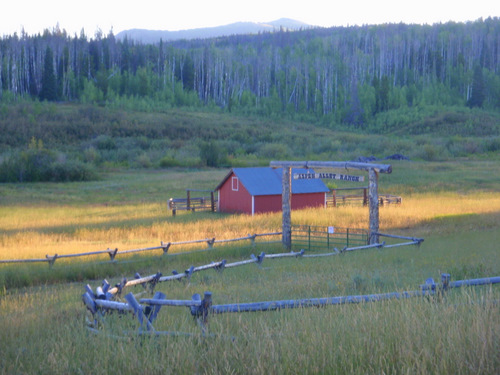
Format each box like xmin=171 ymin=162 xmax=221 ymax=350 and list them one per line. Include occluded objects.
xmin=0 ymin=18 xmax=500 ymax=182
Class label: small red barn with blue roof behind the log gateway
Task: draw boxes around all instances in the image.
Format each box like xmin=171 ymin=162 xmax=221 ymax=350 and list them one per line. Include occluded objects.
xmin=215 ymin=167 xmax=329 ymax=215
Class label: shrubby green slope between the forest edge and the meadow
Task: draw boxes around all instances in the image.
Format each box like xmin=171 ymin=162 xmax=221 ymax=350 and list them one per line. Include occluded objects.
xmin=0 ymin=101 xmax=500 ymax=182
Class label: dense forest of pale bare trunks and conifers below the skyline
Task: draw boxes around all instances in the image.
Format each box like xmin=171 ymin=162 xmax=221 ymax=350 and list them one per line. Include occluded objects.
xmin=0 ymin=18 xmax=500 ymax=128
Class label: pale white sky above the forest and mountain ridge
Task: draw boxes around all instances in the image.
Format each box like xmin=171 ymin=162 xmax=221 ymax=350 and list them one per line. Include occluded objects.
xmin=0 ymin=0 xmax=500 ymax=36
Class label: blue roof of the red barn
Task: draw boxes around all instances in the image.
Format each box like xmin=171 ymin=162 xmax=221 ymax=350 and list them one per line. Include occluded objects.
xmin=219 ymin=167 xmax=329 ymax=196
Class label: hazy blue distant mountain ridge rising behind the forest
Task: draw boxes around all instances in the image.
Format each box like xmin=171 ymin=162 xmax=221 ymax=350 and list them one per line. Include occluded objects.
xmin=116 ymin=18 xmax=313 ymax=43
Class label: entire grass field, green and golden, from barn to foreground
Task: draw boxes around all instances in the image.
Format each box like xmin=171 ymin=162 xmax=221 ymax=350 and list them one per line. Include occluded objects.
xmin=0 ymin=161 xmax=500 ymax=374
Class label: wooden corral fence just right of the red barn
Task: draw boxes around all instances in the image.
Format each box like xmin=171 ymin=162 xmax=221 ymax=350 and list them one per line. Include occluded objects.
xmin=326 ymin=186 xmax=403 ymax=207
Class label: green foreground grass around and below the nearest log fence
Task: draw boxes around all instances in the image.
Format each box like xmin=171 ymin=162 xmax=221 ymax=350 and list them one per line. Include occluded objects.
xmin=0 ymin=231 xmax=500 ymax=374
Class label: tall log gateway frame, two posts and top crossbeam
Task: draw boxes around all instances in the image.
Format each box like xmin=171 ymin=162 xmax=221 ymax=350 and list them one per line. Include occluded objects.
xmin=270 ymin=161 xmax=392 ymax=250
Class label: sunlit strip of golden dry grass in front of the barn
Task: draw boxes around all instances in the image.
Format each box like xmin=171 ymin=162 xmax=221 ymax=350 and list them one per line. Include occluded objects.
xmin=0 ymin=193 xmax=500 ymax=259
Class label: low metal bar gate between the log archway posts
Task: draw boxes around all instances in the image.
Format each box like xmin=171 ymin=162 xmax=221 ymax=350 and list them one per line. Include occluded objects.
xmin=292 ymin=225 xmax=369 ymax=251
